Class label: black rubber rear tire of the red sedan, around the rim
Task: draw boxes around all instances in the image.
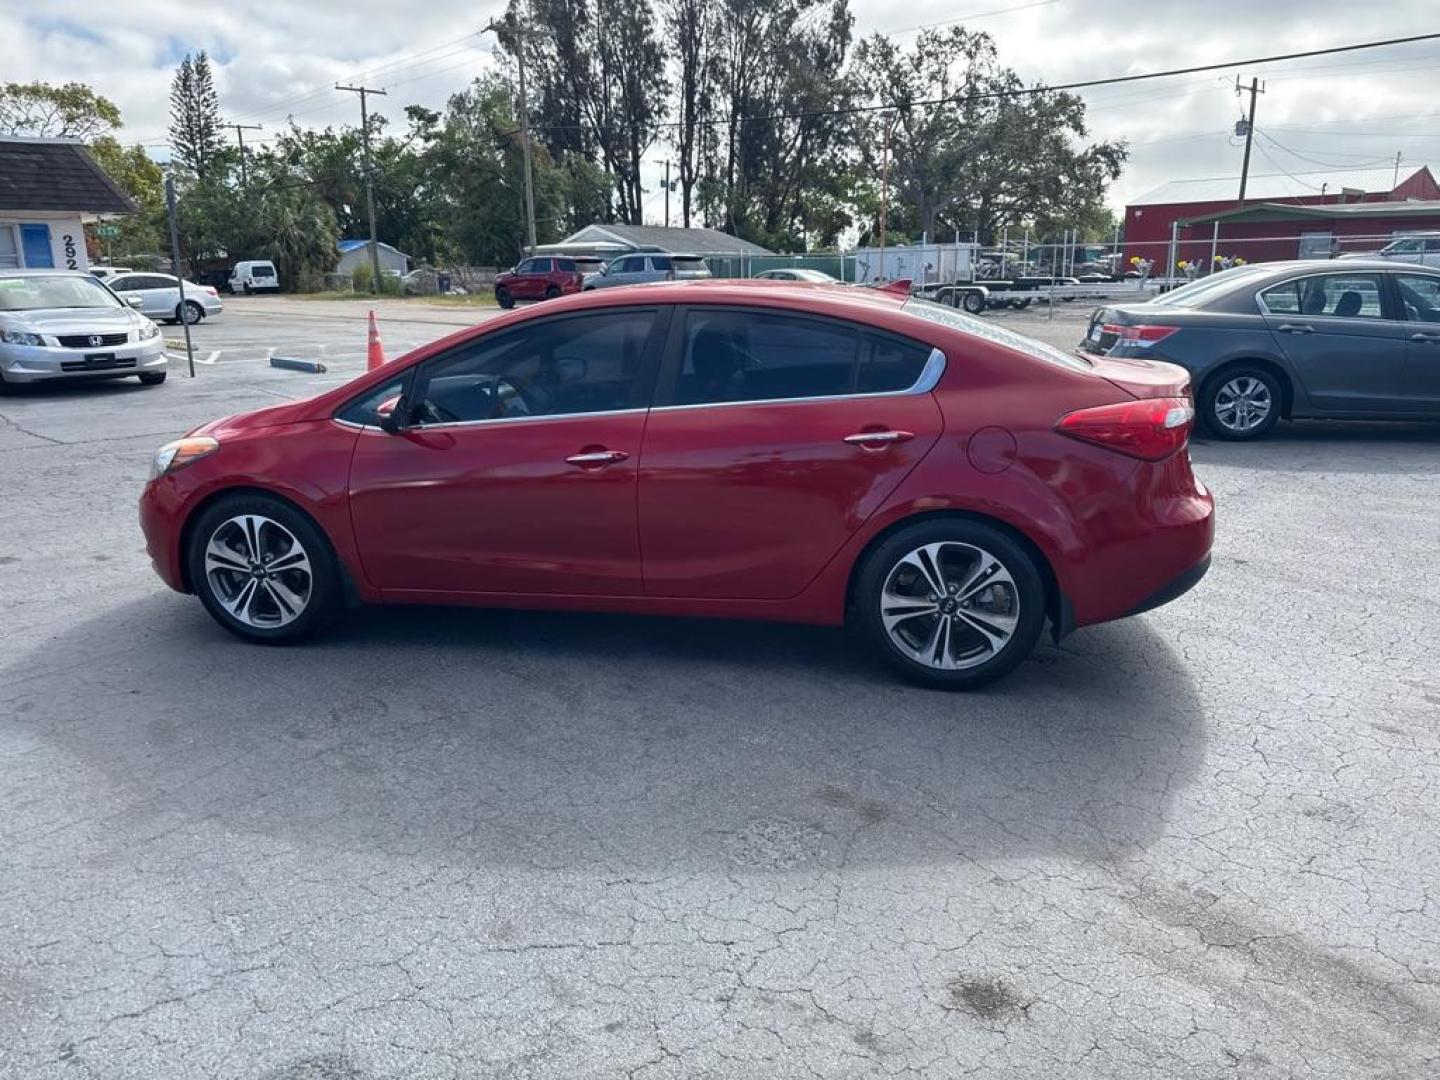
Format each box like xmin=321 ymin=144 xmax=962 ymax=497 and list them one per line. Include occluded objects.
xmin=855 ymin=518 xmax=1045 ymax=690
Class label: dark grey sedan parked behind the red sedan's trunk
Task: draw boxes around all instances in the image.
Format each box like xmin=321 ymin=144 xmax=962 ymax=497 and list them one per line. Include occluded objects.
xmin=1080 ymin=259 xmax=1440 ymax=439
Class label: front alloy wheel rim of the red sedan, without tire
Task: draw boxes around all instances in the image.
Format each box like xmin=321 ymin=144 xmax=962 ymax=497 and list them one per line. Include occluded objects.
xmin=204 ymin=514 xmax=314 ymax=629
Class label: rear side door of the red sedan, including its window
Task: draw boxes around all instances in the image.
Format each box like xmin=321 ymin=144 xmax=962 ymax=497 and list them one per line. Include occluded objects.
xmin=639 ymin=307 xmax=945 ymax=599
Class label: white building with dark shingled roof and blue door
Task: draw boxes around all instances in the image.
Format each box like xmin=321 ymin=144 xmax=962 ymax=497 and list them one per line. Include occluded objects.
xmin=0 ymin=135 xmax=135 ymax=269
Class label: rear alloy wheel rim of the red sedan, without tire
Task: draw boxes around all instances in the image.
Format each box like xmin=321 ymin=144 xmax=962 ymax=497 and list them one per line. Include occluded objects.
xmin=880 ymin=540 xmax=1020 ymax=671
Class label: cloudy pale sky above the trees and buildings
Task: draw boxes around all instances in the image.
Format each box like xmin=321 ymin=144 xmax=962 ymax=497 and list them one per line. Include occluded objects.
xmin=0 ymin=0 xmax=1440 ymax=220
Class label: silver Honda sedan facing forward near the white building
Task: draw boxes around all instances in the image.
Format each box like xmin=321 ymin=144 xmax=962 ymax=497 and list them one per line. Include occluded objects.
xmin=0 ymin=271 xmax=166 ymax=392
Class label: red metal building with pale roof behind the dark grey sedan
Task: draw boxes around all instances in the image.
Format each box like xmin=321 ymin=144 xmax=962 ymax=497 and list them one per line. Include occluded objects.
xmin=1125 ymin=166 xmax=1440 ymax=276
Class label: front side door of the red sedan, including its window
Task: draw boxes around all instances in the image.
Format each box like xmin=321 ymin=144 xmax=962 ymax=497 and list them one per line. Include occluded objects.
xmin=350 ymin=307 xmax=668 ymax=600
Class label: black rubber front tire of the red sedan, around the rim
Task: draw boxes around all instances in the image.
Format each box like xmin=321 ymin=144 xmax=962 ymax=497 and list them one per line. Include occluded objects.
xmin=186 ymin=494 xmax=344 ymax=645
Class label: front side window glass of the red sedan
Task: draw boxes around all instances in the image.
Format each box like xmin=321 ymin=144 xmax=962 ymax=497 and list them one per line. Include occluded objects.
xmin=412 ymin=308 xmax=655 ymax=423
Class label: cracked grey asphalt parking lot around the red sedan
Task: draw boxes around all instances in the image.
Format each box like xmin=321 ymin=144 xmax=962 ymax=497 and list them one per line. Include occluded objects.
xmin=0 ymin=300 xmax=1440 ymax=1080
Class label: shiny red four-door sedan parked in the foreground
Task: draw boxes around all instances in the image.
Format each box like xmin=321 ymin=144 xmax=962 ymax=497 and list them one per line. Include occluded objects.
xmin=140 ymin=281 xmax=1214 ymax=688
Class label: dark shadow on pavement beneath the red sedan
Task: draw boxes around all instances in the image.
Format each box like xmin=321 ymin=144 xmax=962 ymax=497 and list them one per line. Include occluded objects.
xmin=11 ymin=593 xmax=1207 ymax=874
